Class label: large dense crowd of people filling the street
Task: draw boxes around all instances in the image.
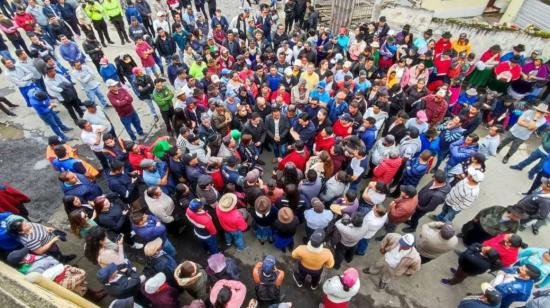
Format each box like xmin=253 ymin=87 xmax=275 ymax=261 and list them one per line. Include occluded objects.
xmin=0 ymin=0 xmax=550 ymax=308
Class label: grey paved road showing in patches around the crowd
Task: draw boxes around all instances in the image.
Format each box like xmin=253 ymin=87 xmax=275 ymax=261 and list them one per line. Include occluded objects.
xmin=0 ymin=0 xmax=550 ymax=308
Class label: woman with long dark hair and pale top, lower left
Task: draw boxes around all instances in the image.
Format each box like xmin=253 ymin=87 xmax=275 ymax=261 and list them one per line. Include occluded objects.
xmin=84 ymin=227 xmax=127 ymax=268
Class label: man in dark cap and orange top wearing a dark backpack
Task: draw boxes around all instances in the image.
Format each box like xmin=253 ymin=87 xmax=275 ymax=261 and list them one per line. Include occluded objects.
xmin=252 ymin=255 xmax=285 ymax=305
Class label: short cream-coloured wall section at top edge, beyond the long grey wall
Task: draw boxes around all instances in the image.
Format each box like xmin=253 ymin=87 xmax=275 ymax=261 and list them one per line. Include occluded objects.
xmin=422 ymin=0 xmax=489 ymax=18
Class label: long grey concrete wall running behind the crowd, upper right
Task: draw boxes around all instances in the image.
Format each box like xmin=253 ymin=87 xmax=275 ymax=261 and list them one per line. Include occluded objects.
xmin=381 ymin=7 xmax=550 ymax=56
